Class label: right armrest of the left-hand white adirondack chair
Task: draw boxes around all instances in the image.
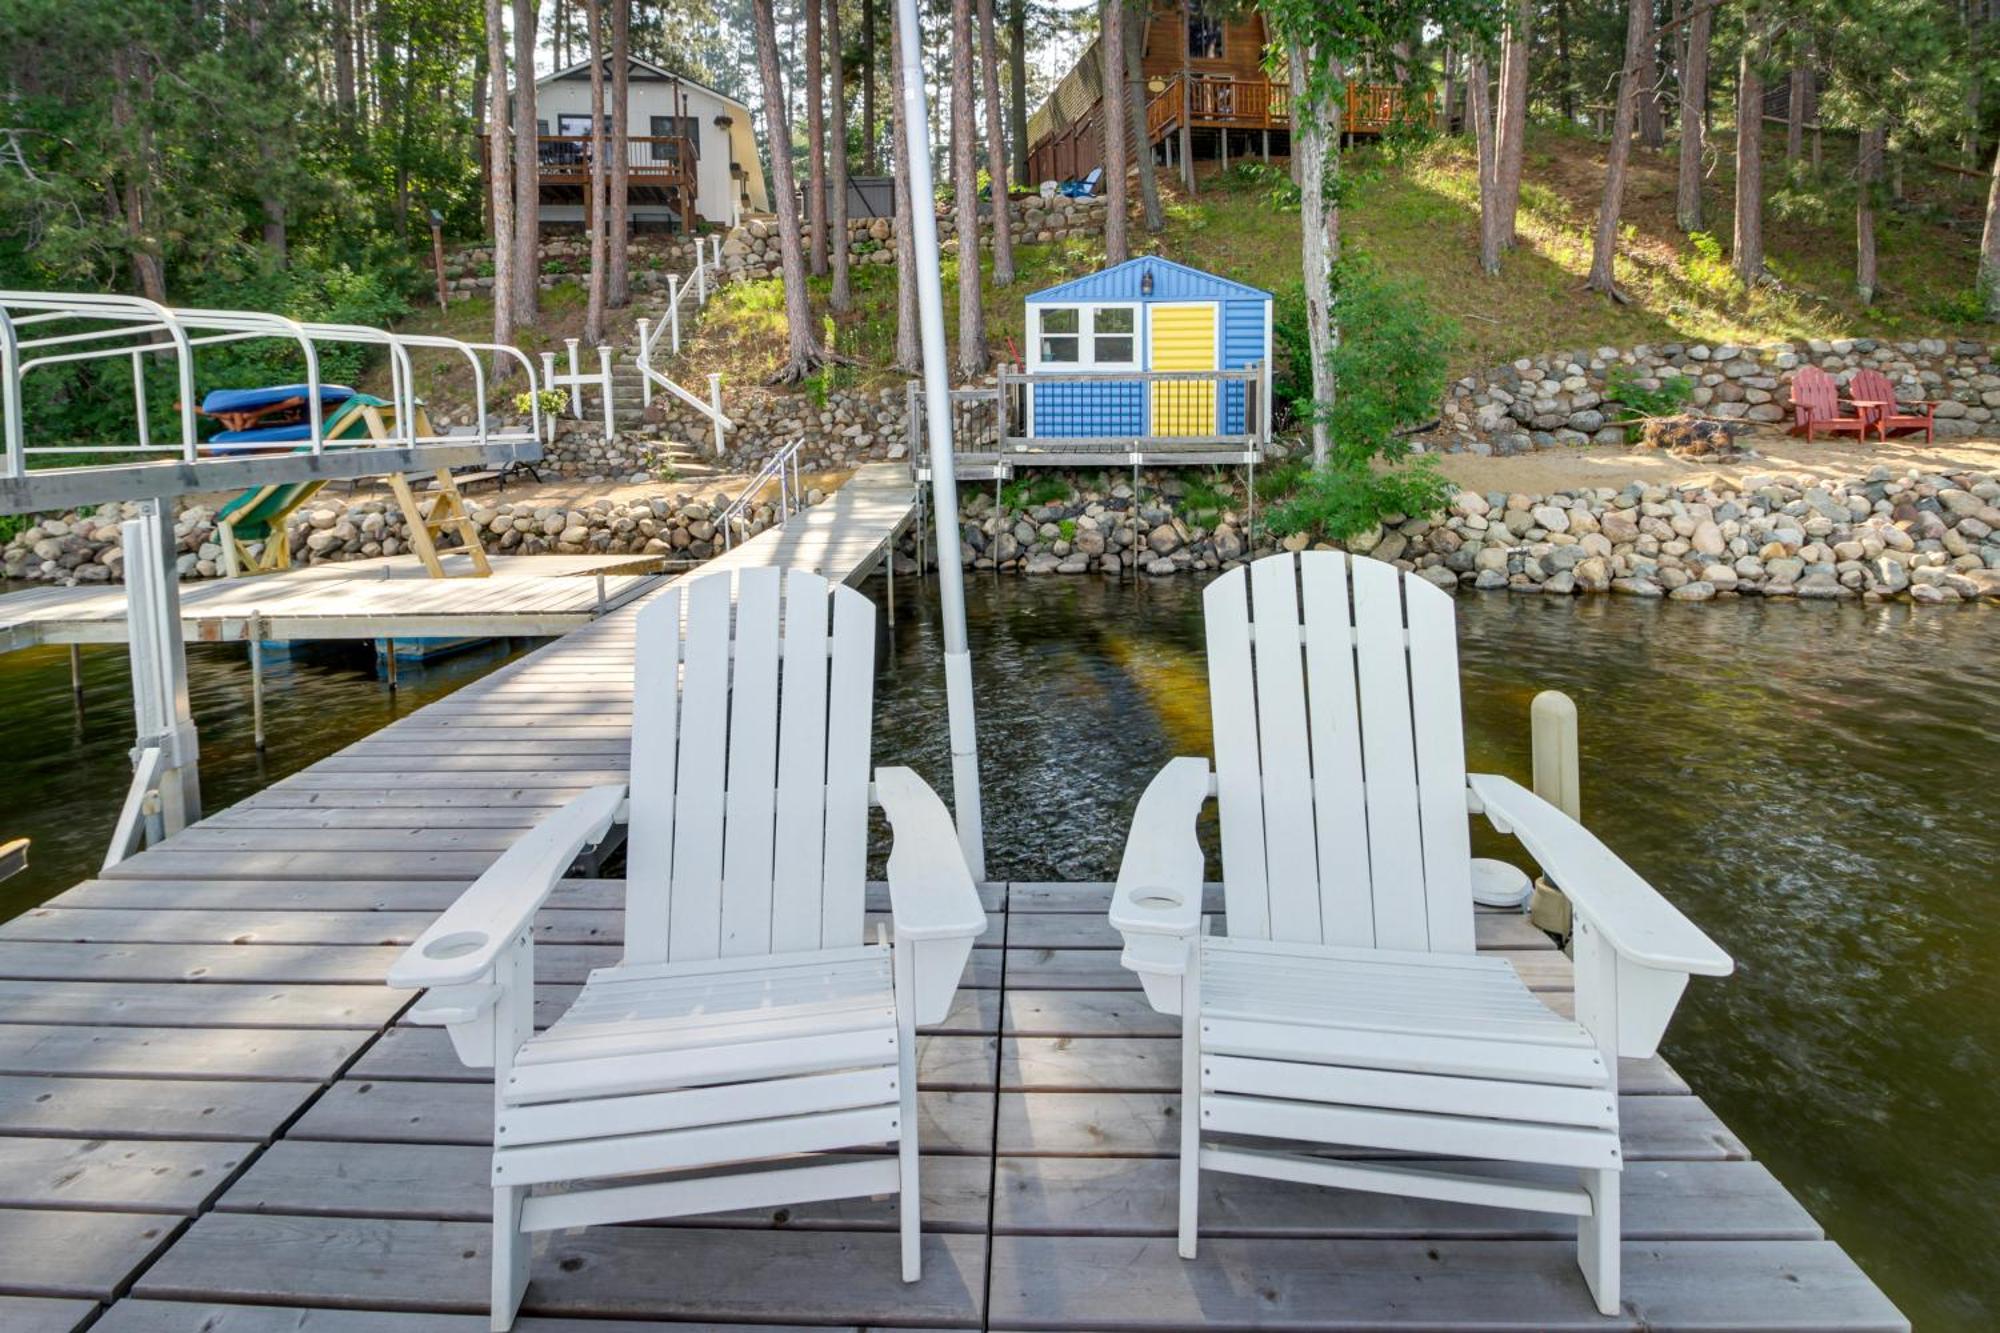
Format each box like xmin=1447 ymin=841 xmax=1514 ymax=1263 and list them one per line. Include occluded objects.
xmin=874 ymin=769 xmax=986 ymax=1025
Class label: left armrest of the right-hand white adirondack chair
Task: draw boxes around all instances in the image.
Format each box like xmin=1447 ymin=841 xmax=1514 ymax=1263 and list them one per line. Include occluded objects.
xmin=1112 ymin=759 xmax=1212 ymax=1013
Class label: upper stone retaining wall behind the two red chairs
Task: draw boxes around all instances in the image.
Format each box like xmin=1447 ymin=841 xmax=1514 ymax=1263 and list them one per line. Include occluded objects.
xmin=1424 ymin=338 xmax=2000 ymax=454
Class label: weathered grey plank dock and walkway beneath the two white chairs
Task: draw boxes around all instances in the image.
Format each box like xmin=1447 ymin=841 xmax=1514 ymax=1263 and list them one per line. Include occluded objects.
xmin=0 ymin=468 xmax=1906 ymax=1333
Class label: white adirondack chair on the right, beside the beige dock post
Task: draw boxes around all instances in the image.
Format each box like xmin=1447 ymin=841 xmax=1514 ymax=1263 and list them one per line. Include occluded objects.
xmin=1112 ymin=552 xmax=1732 ymax=1315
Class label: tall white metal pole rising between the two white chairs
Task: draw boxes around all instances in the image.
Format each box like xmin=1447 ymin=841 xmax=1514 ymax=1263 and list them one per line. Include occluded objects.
xmin=896 ymin=0 xmax=986 ymax=879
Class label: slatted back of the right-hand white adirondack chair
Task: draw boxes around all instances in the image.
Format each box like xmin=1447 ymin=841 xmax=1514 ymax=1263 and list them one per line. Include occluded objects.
xmin=1204 ymin=550 xmax=1474 ymax=953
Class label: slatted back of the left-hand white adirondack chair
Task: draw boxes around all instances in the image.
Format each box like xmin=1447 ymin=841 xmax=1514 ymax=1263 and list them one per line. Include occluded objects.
xmin=626 ymin=568 xmax=876 ymax=963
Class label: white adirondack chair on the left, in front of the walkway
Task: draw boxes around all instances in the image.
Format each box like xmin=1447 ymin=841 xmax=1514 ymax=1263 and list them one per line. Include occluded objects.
xmin=388 ymin=570 xmax=986 ymax=1329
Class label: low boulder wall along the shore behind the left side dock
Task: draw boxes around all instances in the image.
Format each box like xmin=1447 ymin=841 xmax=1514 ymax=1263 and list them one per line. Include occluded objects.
xmin=0 ymin=480 xmax=824 ymax=584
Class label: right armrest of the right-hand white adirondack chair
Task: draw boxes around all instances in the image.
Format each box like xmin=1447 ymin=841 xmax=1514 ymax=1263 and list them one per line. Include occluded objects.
xmin=1466 ymin=773 xmax=1736 ymax=1057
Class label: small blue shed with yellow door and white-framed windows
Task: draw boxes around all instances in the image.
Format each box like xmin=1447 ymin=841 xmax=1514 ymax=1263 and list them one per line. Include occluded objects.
xmin=1026 ymin=256 xmax=1272 ymax=440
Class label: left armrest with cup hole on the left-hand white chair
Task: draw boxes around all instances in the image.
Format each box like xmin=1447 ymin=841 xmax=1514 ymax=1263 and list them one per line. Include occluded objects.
xmin=388 ymin=783 xmax=626 ymax=991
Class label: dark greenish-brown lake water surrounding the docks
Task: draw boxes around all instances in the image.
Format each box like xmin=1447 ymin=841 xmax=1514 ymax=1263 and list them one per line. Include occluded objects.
xmin=0 ymin=578 xmax=2000 ymax=1329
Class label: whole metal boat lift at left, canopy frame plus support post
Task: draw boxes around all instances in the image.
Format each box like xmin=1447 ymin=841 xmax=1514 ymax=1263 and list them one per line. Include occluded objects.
xmin=0 ymin=290 xmax=548 ymax=869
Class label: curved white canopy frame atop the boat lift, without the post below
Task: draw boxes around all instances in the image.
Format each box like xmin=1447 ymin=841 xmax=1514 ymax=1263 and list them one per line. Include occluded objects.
xmin=0 ymin=290 xmax=542 ymax=514
